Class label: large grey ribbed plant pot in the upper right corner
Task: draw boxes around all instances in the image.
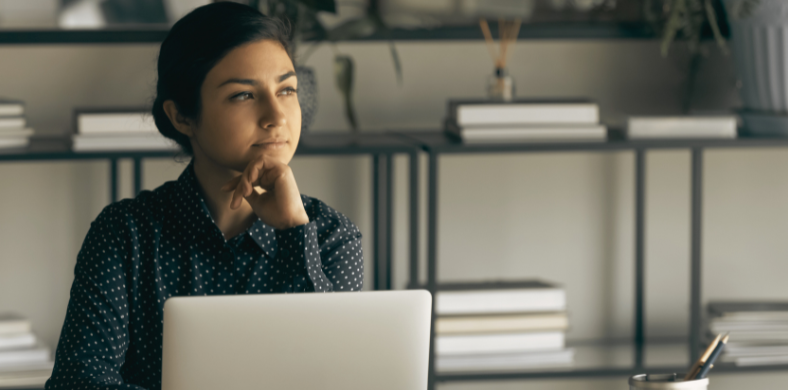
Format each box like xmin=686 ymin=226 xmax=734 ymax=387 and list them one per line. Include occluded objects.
xmin=724 ymin=0 xmax=788 ymax=115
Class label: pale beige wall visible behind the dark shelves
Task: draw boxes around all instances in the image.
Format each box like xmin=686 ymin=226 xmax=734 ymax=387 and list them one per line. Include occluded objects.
xmin=0 ymin=40 xmax=788 ymax=389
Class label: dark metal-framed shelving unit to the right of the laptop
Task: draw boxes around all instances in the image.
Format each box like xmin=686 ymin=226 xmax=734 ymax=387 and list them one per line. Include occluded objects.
xmin=398 ymin=130 xmax=788 ymax=390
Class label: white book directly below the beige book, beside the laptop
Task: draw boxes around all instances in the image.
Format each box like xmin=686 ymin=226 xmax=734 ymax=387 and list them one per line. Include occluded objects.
xmin=435 ymin=332 xmax=564 ymax=356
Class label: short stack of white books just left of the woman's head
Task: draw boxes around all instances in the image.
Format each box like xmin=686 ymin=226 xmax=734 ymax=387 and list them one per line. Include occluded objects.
xmin=72 ymin=109 xmax=178 ymax=152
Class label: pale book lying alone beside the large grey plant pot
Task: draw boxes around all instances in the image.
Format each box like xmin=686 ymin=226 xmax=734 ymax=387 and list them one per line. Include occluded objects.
xmin=627 ymin=116 xmax=736 ymax=139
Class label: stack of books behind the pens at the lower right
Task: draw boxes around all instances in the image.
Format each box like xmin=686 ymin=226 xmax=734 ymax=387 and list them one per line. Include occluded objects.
xmin=708 ymin=302 xmax=788 ymax=366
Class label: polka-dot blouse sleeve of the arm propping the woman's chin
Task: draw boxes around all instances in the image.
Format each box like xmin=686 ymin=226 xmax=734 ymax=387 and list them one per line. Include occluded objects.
xmin=277 ymin=206 xmax=364 ymax=292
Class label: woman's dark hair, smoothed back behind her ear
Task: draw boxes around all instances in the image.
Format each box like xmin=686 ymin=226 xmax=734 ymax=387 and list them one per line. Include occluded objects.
xmin=152 ymin=2 xmax=293 ymax=155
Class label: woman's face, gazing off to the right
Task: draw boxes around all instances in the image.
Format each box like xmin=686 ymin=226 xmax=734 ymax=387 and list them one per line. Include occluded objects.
xmin=191 ymin=40 xmax=301 ymax=172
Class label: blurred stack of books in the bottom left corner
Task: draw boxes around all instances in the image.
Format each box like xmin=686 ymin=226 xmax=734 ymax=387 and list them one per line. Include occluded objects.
xmin=0 ymin=313 xmax=54 ymax=388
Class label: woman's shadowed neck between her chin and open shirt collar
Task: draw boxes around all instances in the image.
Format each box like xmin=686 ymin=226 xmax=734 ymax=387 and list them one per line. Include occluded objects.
xmin=193 ymin=155 xmax=257 ymax=240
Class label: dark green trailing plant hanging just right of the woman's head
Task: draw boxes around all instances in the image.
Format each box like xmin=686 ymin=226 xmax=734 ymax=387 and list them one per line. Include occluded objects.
xmin=258 ymin=0 xmax=402 ymax=131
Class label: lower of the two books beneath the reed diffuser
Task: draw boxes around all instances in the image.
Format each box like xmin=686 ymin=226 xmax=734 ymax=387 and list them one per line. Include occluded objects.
xmin=446 ymin=122 xmax=607 ymax=144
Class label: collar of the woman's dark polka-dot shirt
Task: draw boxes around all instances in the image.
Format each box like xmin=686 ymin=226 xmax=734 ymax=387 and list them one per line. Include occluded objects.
xmin=169 ymin=160 xmax=277 ymax=259
